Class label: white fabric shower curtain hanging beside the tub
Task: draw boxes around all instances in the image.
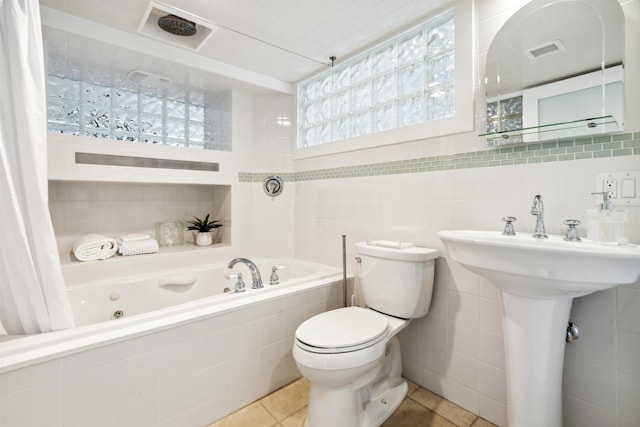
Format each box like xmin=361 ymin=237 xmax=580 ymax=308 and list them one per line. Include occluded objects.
xmin=0 ymin=0 xmax=73 ymax=334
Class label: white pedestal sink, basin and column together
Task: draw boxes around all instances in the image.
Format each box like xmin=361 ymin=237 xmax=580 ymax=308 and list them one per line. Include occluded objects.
xmin=438 ymin=230 xmax=640 ymax=427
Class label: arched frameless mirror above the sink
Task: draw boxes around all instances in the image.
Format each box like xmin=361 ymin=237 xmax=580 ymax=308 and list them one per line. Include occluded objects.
xmin=481 ymin=0 xmax=624 ymax=146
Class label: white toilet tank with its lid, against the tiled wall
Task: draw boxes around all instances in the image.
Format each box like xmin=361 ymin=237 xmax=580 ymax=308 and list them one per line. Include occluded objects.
xmin=356 ymin=241 xmax=439 ymax=319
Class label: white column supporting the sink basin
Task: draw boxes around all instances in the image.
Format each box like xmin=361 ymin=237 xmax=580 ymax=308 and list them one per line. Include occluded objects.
xmin=499 ymin=291 xmax=573 ymax=427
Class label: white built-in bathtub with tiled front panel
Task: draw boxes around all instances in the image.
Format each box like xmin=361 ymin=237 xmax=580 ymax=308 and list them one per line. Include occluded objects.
xmin=0 ymin=259 xmax=353 ymax=426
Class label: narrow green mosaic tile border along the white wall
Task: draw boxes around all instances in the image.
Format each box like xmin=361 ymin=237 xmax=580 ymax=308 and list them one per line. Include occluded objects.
xmin=239 ymin=132 xmax=640 ymax=182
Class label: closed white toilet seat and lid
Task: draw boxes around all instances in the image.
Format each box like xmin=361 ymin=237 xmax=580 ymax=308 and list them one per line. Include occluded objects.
xmin=296 ymin=307 xmax=389 ymax=354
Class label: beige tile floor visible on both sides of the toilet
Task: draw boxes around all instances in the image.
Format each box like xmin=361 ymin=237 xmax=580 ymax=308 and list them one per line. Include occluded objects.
xmin=209 ymin=378 xmax=495 ymax=427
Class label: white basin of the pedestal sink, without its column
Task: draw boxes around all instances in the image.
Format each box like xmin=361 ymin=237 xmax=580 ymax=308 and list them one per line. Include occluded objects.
xmin=438 ymin=230 xmax=640 ymax=298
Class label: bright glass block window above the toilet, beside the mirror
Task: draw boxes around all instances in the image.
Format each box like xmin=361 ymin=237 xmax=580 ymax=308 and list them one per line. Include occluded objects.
xmin=297 ymin=11 xmax=455 ymax=148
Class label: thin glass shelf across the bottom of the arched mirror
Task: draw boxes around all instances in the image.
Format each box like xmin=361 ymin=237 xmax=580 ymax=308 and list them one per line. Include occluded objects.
xmin=479 ymin=115 xmax=621 ymax=146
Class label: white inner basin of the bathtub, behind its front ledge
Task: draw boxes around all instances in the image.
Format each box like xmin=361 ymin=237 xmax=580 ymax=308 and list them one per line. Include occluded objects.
xmin=67 ymin=259 xmax=341 ymax=326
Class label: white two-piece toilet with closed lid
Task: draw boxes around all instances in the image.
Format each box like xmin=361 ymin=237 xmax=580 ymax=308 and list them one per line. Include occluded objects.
xmin=293 ymin=241 xmax=439 ymax=427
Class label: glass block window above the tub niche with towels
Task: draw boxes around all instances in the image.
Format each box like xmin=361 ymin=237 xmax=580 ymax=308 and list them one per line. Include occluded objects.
xmin=47 ymin=75 xmax=219 ymax=149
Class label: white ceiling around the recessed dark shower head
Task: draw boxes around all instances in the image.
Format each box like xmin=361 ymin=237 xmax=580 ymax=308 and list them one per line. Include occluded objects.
xmin=40 ymin=0 xmax=448 ymax=92
